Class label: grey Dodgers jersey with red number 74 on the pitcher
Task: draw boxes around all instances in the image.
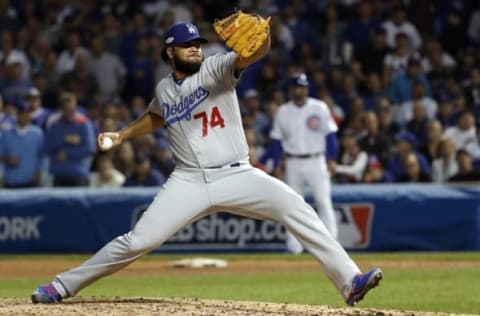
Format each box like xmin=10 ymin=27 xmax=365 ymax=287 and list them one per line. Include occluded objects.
xmin=148 ymin=52 xmax=248 ymax=168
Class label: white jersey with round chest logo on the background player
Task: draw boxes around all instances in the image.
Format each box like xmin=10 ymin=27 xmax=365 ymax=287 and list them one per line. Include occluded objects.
xmin=270 ymin=98 xmax=338 ymax=155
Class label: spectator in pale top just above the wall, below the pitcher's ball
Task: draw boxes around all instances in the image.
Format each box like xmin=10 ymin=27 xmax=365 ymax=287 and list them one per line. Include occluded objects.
xmin=90 ymin=154 xmax=125 ymax=188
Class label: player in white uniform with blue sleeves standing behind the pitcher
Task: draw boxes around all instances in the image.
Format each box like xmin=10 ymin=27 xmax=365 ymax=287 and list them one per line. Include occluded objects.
xmin=270 ymin=73 xmax=338 ymax=254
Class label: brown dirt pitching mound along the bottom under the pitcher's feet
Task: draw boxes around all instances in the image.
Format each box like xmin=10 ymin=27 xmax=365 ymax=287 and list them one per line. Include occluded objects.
xmin=0 ymin=297 xmax=468 ymax=316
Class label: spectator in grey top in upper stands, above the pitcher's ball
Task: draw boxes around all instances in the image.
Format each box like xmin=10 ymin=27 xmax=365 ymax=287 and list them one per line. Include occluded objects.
xmin=88 ymin=35 xmax=127 ymax=101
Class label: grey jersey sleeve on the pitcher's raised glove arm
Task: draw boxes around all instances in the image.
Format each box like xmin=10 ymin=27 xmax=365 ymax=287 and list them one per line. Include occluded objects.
xmin=205 ymin=52 xmax=238 ymax=87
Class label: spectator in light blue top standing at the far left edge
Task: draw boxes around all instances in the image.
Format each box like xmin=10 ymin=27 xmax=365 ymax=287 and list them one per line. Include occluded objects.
xmin=0 ymin=102 xmax=45 ymax=188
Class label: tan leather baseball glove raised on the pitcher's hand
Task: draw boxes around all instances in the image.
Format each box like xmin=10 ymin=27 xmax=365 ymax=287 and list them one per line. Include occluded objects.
xmin=213 ymin=11 xmax=270 ymax=58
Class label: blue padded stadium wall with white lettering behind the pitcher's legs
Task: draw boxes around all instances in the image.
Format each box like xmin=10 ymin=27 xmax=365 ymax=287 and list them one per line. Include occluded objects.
xmin=0 ymin=184 xmax=480 ymax=254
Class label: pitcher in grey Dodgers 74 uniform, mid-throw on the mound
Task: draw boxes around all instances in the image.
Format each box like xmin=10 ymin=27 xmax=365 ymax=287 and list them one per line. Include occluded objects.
xmin=31 ymin=13 xmax=382 ymax=305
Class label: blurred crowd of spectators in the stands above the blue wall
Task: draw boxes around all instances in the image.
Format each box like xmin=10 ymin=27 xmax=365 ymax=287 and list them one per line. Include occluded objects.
xmin=0 ymin=0 xmax=480 ymax=188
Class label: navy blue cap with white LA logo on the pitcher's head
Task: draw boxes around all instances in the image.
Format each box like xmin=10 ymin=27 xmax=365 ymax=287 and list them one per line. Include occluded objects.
xmin=162 ymin=22 xmax=208 ymax=61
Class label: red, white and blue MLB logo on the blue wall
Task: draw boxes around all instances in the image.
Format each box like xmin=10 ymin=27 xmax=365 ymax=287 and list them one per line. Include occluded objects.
xmin=335 ymin=203 xmax=375 ymax=249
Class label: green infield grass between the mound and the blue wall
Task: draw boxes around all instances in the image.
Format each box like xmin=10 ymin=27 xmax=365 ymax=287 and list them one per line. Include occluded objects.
xmin=0 ymin=253 xmax=480 ymax=313
